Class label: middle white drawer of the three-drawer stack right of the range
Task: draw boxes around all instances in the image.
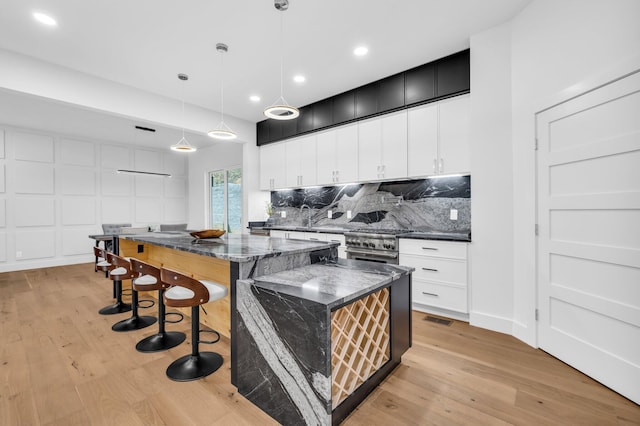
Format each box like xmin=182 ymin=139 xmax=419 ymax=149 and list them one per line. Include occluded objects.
xmin=400 ymin=254 xmax=467 ymax=286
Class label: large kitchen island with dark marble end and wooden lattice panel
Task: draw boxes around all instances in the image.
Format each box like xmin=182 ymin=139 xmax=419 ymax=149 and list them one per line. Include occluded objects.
xmin=119 ymin=233 xmax=413 ymax=424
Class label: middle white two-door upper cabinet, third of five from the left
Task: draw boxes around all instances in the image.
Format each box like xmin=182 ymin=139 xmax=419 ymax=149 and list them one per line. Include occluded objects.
xmin=317 ymin=124 xmax=358 ymax=185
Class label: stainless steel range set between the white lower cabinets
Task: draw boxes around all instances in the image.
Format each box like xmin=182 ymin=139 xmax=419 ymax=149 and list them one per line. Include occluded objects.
xmin=344 ymin=229 xmax=406 ymax=265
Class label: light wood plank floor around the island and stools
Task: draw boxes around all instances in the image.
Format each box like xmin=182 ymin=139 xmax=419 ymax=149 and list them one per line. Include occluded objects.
xmin=0 ymin=264 xmax=640 ymax=426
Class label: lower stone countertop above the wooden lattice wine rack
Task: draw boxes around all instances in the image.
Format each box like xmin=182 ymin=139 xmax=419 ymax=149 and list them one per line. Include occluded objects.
xmin=253 ymin=259 xmax=414 ymax=309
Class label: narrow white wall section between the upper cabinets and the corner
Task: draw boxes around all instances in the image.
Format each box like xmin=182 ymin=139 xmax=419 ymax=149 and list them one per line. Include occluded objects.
xmin=469 ymin=23 xmax=513 ymax=334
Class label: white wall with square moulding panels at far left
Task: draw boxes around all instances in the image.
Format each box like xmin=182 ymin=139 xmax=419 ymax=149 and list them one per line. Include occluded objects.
xmin=0 ymin=125 xmax=187 ymax=272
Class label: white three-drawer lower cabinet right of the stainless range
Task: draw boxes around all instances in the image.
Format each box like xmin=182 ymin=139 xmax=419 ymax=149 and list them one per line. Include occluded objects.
xmin=399 ymin=238 xmax=469 ymax=319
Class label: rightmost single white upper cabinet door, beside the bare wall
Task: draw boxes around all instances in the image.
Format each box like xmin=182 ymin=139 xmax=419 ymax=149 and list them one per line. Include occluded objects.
xmin=438 ymin=95 xmax=471 ymax=173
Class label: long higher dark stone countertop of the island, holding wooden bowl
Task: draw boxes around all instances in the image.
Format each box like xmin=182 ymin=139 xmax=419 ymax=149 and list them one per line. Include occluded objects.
xmin=120 ymin=232 xmax=339 ymax=262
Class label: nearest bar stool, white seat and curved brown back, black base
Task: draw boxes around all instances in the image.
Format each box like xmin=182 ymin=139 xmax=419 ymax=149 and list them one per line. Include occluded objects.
xmin=160 ymin=268 xmax=227 ymax=382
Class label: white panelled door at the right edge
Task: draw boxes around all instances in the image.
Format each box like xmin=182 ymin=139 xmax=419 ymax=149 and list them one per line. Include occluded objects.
xmin=536 ymin=72 xmax=640 ymax=403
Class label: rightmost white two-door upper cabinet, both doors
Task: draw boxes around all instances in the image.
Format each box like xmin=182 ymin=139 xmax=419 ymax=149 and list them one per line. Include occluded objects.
xmin=408 ymin=95 xmax=471 ymax=177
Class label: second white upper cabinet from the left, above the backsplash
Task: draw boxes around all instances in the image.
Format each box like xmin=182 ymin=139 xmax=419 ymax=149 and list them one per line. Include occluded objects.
xmin=285 ymin=135 xmax=316 ymax=187
